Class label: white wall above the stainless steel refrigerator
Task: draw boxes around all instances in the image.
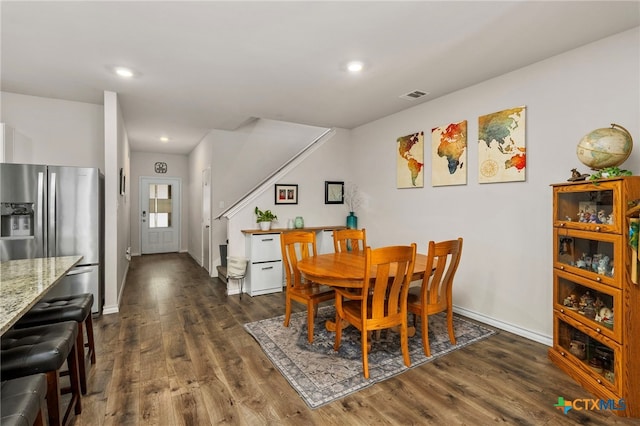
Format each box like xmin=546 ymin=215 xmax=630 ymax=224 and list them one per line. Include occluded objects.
xmin=0 ymin=92 xmax=105 ymax=171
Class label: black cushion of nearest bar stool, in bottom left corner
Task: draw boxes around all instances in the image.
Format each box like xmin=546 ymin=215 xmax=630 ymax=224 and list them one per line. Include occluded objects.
xmin=0 ymin=374 xmax=47 ymax=426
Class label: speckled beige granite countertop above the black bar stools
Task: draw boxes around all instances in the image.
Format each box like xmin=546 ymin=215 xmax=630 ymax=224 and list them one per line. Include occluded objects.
xmin=0 ymin=256 xmax=82 ymax=334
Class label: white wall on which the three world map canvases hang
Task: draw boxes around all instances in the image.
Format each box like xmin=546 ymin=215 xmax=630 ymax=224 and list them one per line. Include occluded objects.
xmin=350 ymin=28 xmax=640 ymax=344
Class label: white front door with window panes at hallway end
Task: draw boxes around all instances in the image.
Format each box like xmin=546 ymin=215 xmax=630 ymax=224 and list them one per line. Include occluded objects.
xmin=140 ymin=177 xmax=181 ymax=254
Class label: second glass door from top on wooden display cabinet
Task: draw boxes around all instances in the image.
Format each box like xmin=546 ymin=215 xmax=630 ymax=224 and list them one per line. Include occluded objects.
xmin=553 ymin=228 xmax=624 ymax=287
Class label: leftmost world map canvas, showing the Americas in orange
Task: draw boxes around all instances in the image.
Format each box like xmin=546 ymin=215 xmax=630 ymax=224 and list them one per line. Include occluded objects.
xmin=396 ymin=132 xmax=424 ymax=188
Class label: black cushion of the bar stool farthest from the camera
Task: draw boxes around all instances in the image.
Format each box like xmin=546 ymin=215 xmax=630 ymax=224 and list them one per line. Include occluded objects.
xmin=13 ymin=293 xmax=93 ymax=328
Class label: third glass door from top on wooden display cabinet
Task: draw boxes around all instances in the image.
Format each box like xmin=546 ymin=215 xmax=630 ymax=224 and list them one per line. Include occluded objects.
xmin=553 ymin=269 xmax=624 ymax=343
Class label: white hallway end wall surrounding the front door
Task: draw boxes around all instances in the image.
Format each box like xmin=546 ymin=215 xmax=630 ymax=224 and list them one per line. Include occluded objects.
xmin=127 ymin=151 xmax=190 ymax=255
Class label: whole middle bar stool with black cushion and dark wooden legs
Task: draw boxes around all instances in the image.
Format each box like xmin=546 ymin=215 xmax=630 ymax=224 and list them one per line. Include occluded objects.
xmin=0 ymin=321 xmax=82 ymax=426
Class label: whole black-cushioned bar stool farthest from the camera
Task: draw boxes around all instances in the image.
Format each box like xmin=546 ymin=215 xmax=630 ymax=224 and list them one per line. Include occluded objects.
xmin=13 ymin=293 xmax=96 ymax=395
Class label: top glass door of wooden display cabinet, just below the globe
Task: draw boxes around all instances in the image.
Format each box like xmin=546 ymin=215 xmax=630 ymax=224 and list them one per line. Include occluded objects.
xmin=553 ymin=182 xmax=622 ymax=233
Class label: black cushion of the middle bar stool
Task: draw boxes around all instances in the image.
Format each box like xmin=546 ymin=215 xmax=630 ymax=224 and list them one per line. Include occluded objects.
xmin=0 ymin=321 xmax=78 ymax=380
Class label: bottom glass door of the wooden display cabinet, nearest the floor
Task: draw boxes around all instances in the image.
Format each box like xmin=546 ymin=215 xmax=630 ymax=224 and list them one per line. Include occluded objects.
xmin=553 ymin=311 xmax=623 ymax=394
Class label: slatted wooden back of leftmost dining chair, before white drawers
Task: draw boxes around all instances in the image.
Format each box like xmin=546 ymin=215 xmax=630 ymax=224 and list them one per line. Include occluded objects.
xmin=280 ymin=231 xmax=318 ymax=290
